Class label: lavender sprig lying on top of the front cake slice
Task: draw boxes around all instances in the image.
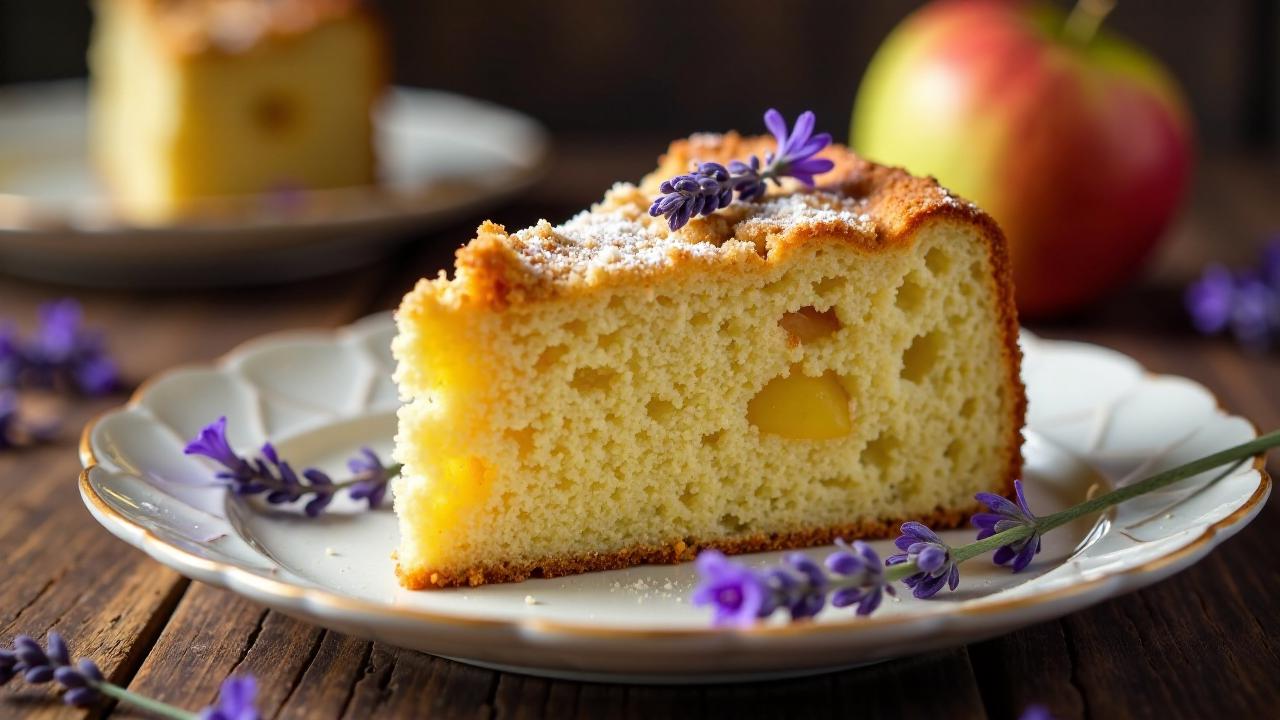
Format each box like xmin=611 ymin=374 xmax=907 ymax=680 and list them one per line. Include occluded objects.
xmin=649 ymin=108 xmax=835 ymax=231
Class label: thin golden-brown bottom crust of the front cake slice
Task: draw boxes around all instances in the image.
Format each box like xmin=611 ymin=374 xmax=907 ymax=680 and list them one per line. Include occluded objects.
xmin=396 ymin=499 xmax=974 ymax=591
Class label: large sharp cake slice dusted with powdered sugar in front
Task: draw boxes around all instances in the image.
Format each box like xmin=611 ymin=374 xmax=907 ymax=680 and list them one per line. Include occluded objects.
xmin=394 ymin=135 xmax=1025 ymax=588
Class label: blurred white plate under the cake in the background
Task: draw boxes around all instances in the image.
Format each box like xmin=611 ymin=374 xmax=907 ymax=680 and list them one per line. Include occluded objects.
xmin=0 ymin=81 xmax=549 ymax=287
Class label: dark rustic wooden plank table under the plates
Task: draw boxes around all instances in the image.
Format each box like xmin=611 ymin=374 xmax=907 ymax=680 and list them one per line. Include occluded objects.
xmin=0 ymin=148 xmax=1280 ymax=719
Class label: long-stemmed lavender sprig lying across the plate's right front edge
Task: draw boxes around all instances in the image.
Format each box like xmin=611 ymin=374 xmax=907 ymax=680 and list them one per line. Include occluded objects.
xmin=692 ymin=430 xmax=1280 ymax=625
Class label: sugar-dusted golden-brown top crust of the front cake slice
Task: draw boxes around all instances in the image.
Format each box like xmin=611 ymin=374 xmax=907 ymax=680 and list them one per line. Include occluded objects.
xmin=430 ymin=133 xmax=1007 ymax=311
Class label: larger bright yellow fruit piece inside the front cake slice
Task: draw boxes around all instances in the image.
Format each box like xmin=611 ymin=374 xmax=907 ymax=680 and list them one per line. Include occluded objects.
xmin=746 ymin=368 xmax=852 ymax=439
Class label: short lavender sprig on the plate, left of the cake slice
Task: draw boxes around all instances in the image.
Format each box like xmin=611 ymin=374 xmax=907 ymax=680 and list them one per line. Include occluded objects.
xmin=183 ymin=415 xmax=401 ymax=518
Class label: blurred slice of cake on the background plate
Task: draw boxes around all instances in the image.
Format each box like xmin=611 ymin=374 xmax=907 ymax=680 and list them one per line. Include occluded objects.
xmin=90 ymin=0 xmax=387 ymax=223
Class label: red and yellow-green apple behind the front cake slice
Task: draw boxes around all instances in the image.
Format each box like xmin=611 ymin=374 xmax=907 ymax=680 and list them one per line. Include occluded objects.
xmin=850 ymin=0 xmax=1193 ymax=318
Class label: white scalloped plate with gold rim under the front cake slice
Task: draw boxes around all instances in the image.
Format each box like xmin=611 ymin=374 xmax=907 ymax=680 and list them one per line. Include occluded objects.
xmin=81 ymin=315 xmax=1271 ymax=683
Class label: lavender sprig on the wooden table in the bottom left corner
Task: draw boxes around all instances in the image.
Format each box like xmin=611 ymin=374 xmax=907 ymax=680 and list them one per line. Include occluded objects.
xmin=0 ymin=630 xmax=261 ymax=720
